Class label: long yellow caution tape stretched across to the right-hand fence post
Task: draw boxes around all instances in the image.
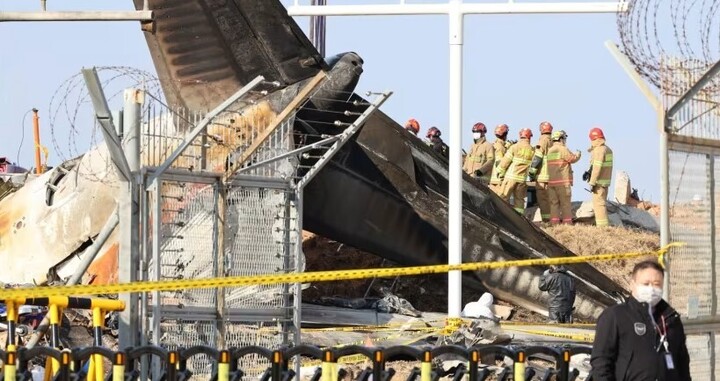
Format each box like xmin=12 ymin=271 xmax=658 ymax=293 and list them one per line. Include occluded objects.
xmin=0 ymin=243 xmax=682 ymax=300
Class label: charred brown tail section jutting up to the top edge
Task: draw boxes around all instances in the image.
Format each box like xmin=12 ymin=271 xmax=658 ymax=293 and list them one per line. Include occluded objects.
xmin=133 ymin=0 xmax=328 ymax=111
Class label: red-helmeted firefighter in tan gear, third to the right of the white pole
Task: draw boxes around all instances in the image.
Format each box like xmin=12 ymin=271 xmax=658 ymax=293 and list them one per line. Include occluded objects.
xmin=498 ymin=128 xmax=535 ymax=214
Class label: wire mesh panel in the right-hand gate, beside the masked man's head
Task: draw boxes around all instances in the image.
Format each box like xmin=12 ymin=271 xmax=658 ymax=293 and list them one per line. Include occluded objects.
xmin=669 ymin=151 xmax=714 ymax=316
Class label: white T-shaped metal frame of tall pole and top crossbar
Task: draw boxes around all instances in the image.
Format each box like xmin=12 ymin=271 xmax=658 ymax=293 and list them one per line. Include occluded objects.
xmin=288 ymin=0 xmax=627 ymax=317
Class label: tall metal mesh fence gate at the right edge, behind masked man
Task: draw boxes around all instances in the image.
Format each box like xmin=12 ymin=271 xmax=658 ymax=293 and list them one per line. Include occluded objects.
xmin=663 ymin=62 xmax=720 ymax=380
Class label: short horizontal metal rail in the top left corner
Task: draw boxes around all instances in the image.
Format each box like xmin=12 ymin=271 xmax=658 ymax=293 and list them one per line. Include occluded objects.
xmin=0 ymin=10 xmax=153 ymax=22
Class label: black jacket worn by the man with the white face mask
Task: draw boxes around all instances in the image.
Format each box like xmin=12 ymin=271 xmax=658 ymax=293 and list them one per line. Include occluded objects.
xmin=590 ymin=297 xmax=691 ymax=381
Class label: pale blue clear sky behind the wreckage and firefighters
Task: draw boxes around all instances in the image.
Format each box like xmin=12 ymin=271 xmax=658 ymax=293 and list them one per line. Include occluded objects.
xmin=0 ymin=0 xmax=660 ymax=202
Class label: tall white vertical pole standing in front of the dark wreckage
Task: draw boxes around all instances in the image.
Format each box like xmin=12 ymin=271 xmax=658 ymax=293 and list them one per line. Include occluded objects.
xmin=448 ymin=0 xmax=464 ymax=317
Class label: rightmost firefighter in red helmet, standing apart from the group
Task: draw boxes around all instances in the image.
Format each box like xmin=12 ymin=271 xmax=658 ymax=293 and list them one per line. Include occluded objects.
xmin=583 ymin=127 xmax=613 ymax=226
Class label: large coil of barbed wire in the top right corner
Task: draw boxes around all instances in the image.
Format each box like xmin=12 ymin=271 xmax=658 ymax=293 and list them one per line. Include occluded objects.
xmin=617 ymin=0 xmax=720 ymax=96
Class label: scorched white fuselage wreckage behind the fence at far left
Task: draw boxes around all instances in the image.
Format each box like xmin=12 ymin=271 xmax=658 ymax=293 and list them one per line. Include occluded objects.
xmin=0 ymin=148 xmax=119 ymax=283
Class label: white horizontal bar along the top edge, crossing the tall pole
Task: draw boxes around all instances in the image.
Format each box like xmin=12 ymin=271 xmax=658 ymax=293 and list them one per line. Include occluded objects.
xmin=288 ymin=0 xmax=627 ymax=16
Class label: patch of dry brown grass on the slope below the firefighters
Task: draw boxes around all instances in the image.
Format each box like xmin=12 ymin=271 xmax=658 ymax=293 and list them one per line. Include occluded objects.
xmin=544 ymin=225 xmax=660 ymax=288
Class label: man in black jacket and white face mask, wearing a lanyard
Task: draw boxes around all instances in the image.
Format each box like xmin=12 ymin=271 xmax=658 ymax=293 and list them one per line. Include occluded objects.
xmin=590 ymin=261 xmax=691 ymax=381
